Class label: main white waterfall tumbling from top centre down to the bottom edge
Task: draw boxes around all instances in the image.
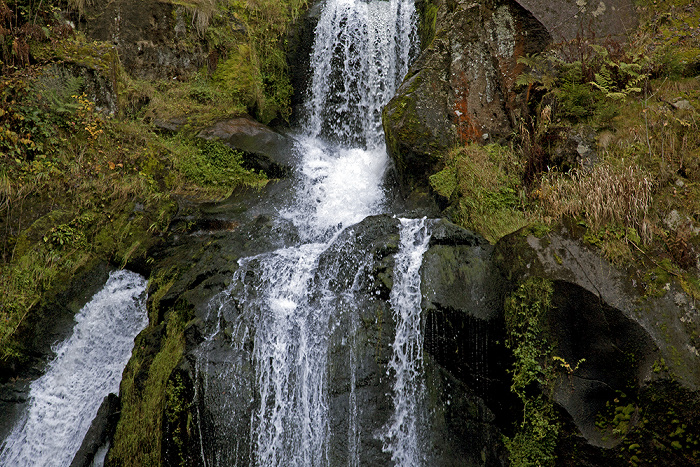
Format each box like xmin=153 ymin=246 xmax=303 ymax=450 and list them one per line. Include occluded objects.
xmin=199 ymin=0 xmax=424 ymax=466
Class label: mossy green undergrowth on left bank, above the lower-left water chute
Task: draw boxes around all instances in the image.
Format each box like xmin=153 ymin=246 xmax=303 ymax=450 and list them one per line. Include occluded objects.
xmin=0 ymin=33 xmax=266 ymax=367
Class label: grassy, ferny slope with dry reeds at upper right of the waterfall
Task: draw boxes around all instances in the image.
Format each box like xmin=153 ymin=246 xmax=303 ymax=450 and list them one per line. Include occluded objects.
xmin=430 ymin=0 xmax=700 ymax=282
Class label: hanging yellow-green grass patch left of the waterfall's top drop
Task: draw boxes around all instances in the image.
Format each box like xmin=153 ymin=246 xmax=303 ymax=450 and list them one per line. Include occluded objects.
xmin=122 ymin=0 xmax=308 ymax=128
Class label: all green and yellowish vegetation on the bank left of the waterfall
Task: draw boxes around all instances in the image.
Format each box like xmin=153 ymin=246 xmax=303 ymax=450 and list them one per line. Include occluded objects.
xmin=0 ymin=0 xmax=314 ymax=368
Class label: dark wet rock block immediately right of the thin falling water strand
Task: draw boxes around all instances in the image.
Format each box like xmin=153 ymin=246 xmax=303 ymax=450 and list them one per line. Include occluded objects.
xmin=421 ymin=219 xmax=515 ymax=426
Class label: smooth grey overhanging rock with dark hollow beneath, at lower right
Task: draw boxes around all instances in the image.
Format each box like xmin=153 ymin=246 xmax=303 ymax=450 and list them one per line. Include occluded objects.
xmin=494 ymin=227 xmax=700 ymax=447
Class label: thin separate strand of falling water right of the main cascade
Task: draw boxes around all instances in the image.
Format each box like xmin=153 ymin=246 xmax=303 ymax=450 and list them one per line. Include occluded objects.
xmin=384 ymin=218 xmax=430 ymax=467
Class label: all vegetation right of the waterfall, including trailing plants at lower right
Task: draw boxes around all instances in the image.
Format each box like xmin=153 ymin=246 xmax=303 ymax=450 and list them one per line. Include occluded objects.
xmin=430 ymin=0 xmax=700 ymax=465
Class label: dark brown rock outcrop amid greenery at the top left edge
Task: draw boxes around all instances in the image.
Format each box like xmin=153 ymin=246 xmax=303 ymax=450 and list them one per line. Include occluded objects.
xmin=81 ymin=0 xmax=207 ymax=79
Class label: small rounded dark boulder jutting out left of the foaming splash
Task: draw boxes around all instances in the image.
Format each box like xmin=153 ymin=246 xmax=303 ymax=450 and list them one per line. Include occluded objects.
xmin=197 ymin=117 xmax=294 ymax=178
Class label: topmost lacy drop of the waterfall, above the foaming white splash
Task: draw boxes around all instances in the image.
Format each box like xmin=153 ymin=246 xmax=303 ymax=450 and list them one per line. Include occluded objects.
xmin=305 ymin=0 xmax=417 ymax=149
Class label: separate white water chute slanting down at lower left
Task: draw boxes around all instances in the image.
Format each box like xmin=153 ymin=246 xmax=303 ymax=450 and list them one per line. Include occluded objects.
xmin=0 ymin=271 xmax=148 ymax=467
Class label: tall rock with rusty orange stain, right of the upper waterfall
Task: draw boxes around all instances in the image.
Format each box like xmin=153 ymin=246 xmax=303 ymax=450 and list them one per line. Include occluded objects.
xmin=382 ymin=0 xmax=550 ymax=188
